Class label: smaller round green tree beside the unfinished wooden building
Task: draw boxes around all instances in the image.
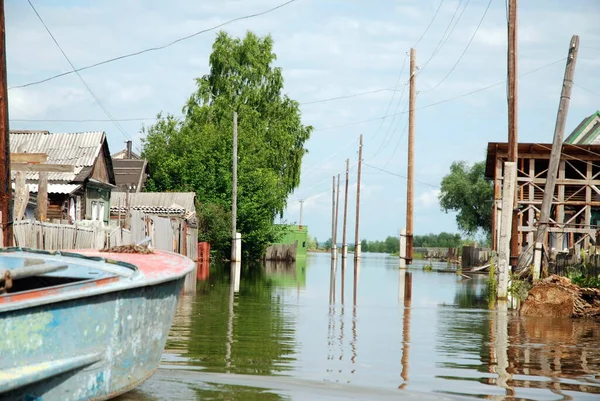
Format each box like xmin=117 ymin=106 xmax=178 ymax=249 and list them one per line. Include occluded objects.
xmin=439 ymin=161 xmax=494 ymax=235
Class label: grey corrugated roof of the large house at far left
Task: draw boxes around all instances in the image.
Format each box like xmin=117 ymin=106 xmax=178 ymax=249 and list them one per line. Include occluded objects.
xmin=10 ymin=131 xmax=105 ymax=181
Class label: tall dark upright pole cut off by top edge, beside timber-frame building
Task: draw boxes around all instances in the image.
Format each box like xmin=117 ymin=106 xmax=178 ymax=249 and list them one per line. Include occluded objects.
xmin=508 ymin=0 xmax=519 ymax=266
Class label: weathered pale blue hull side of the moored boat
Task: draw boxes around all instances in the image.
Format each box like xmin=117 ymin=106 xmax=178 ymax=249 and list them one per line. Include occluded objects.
xmin=0 ymin=277 xmax=185 ymax=401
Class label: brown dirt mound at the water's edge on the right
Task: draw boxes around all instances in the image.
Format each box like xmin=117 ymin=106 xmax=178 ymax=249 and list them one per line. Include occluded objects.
xmin=519 ymin=275 xmax=600 ymax=318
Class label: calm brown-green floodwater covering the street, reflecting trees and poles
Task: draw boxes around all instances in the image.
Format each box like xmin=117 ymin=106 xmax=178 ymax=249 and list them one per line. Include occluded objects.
xmin=118 ymin=254 xmax=600 ymax=401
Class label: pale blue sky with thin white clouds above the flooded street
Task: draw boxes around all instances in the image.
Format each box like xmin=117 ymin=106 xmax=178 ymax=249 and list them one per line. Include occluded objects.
xmin=5 ymin=0 xmax=600 ymax=243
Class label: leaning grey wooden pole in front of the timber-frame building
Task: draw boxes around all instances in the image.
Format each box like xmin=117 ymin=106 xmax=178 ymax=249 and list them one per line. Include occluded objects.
xmin=533 ymin=35 xmax=589 ymax=280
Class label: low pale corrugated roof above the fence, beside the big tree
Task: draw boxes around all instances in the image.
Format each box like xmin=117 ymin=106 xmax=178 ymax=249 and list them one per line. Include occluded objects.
xmin=110 ymin=191 xmax=196 ymax=213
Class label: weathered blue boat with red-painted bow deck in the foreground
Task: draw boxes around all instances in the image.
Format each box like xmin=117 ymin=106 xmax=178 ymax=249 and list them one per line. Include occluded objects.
xmin=0 ymin=248 xmax=194 ymax=401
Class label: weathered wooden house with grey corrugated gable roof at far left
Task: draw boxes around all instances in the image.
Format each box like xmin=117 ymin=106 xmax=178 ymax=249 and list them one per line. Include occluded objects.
xmin=10 ymin=130 xmax=115 ymax=223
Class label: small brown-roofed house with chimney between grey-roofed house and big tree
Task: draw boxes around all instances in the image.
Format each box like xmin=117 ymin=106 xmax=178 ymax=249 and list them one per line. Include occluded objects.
xmin=112 ymin=141 xmax=149 ymax=193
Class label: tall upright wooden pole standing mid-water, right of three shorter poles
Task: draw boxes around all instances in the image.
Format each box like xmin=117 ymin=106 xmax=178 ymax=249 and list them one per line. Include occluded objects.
xmin=406 ymin=49 xmax=417 ymax=265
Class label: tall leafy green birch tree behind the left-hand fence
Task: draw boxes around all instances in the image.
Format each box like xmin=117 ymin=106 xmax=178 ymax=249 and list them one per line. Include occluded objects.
xmin=142 ymin=32 xmax=312 ymax=259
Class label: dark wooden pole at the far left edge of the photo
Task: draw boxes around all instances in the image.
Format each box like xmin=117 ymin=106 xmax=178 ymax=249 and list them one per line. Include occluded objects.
xmin=0 ymin=0 xmax=13 ymax=247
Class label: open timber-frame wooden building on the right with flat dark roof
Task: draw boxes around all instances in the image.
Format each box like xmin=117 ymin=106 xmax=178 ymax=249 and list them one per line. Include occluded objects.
xmin=485 ymin=141 xmax=600 ymax=253
